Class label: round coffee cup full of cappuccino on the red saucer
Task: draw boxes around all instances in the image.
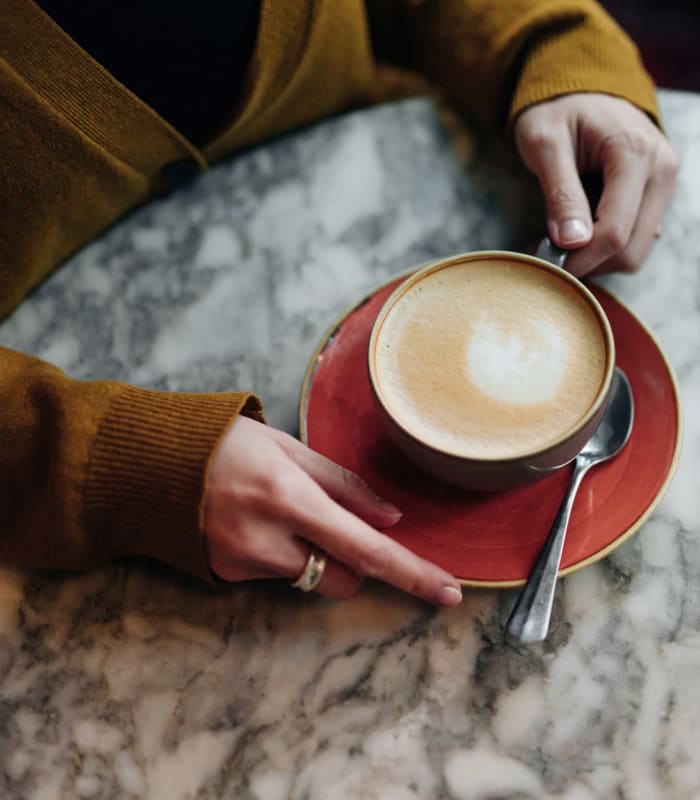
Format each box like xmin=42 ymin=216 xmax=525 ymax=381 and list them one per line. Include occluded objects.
xmin=368 ymin=245 xmax=615 ymax=491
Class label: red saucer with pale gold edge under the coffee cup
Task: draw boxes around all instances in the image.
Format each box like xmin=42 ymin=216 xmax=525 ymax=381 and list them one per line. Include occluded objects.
xmin=299 ymin=275 xmax=681 ymax=587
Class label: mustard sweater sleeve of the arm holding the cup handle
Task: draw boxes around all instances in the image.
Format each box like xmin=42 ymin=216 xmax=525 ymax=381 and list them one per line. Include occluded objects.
xmin=368 ymin=0 xmax=658 ymax=130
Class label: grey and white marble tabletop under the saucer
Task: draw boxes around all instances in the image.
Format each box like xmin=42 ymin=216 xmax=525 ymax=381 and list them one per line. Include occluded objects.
xmin=0 ymin=91 xmax=700 ymax=800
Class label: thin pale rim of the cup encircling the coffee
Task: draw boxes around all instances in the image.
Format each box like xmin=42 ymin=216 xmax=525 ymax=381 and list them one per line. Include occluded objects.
xmin=367 ymin=250 xmax=615 ymax=466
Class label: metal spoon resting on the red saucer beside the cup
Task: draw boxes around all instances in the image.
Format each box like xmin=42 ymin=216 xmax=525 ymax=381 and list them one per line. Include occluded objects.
xmin=506 ymin=368 xmax=634 ymax=642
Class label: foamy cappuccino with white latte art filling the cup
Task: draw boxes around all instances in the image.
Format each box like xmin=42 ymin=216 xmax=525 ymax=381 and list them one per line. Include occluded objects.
xmin=372 ymin=254 xmax=609 ymax=460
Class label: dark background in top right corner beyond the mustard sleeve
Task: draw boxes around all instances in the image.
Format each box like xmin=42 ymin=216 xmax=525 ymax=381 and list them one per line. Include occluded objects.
xmin=601 ymin=0 xmax=700 ymax=92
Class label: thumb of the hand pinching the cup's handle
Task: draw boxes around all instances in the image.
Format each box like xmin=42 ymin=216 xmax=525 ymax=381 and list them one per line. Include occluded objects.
xmin=518 ymin=120 xmax=593 ymax=249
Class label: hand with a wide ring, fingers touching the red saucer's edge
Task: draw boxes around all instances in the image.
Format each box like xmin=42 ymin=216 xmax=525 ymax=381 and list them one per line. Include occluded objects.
xmin=205 ymin=417 xmax=461 ymax=606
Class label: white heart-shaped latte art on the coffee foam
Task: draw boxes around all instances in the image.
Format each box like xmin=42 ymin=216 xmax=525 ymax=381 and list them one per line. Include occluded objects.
xmin=465 ymin=319 xmax=568 ymax=406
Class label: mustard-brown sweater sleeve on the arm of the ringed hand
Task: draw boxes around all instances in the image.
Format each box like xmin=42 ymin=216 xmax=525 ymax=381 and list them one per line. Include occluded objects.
xmin=0 ymin=348 xmax=261 ymax=581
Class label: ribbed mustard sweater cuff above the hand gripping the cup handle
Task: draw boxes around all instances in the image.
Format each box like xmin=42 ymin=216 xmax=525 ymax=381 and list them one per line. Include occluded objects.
xmin=509 ymin=6 xmax=660 ymax=125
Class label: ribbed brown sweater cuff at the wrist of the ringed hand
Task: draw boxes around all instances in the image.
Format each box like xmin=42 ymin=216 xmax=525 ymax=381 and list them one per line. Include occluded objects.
xmin=85 ymin=386 xmax=262 ymax=582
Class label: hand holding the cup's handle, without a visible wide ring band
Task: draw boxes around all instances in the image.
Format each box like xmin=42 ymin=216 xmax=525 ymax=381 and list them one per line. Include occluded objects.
xmin=515 ymin=93 xmax=679 ymax=276
